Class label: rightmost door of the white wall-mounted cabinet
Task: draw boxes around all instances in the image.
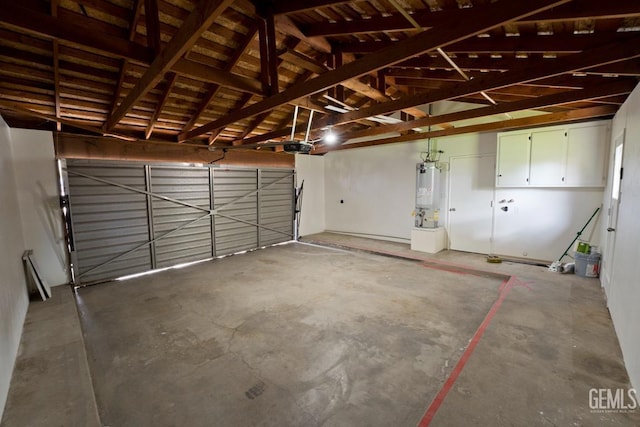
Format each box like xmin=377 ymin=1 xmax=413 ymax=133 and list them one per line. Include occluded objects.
xmin=566 ymin=125 xmax=609 ymax=187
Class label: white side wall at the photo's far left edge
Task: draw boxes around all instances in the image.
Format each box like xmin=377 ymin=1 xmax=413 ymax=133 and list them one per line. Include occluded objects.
xmin=0 ymin=116 xmax=29 ymax=419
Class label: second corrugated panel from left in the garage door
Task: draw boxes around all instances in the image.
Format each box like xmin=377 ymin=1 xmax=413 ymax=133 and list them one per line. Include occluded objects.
xmin=150 ymin=167 xmax=213 ymax=268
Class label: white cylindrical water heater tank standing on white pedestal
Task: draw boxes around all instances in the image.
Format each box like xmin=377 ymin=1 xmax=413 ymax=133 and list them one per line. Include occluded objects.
xmin=415 ymin=162 xmax=440 ymax=228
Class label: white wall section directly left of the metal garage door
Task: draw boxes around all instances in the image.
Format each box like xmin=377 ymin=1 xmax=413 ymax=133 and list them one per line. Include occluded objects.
xmin=10 ymin=129 xmax=69 ymax=286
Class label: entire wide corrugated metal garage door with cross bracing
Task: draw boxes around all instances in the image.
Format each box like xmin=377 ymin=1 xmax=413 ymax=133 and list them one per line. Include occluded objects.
xmin=64 ymin=160 xmax=295 ymax=284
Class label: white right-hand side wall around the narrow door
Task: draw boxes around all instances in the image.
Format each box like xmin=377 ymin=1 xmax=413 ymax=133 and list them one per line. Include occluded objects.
xmin=604 ymin=85 xmax=640 ymax=388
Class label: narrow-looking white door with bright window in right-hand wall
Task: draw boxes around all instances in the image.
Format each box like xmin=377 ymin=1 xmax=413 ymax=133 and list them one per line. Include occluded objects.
xmin=601 ymin=132 xmax=624 ymax=295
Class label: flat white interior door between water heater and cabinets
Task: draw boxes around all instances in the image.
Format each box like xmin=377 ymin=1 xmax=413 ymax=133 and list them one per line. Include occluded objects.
xmin=449 ymin=155 xmax=495 ymax=254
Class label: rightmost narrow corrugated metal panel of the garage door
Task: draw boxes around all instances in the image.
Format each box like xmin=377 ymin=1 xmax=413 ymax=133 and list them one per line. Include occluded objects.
xmin=259 ymin=170 xmax=294 ymax=246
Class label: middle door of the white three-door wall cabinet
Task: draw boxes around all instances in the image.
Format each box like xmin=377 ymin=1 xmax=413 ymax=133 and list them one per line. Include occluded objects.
xmin=529 ymin=129 xmax=567 ymax=187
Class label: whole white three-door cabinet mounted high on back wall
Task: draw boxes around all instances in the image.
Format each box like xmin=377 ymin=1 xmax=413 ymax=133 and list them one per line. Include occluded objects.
xmin=496 ymin=123 xmax=609 ymax=187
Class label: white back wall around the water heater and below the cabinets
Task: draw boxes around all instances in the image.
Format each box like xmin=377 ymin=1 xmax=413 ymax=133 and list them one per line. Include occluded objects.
xmin=324 ymin=122 xmax=606 ymax=261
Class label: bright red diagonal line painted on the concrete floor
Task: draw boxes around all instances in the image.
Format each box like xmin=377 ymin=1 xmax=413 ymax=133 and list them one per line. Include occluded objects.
xmin=418 ymin=276 xmax=519 ymax=427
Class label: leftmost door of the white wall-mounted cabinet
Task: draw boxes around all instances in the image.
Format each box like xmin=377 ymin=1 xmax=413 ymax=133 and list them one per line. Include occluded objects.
xmin=496 ymin=132 xmax=531 ymax=187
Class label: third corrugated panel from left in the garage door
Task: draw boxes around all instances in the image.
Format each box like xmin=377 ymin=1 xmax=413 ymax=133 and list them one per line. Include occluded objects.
xmin=213 ymin=169 xmax=258 ymax=256
